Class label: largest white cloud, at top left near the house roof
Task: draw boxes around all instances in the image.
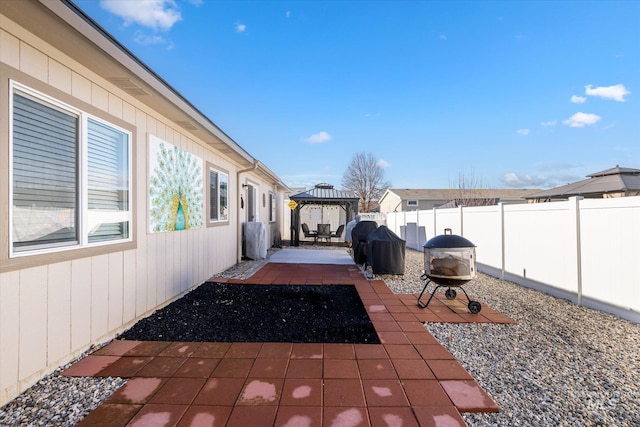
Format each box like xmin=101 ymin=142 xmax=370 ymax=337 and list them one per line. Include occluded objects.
xmin=100 ymin=0 xmax=182 ymax=31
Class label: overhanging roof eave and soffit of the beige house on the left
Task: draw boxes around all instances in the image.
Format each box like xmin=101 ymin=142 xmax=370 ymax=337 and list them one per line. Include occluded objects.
xmin=0 ymin=0 xmax=287 ymax=190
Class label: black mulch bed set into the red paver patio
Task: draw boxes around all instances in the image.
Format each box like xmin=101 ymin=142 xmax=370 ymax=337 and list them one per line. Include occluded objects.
xmin=119 ymin=283 xmax=380 ymax=344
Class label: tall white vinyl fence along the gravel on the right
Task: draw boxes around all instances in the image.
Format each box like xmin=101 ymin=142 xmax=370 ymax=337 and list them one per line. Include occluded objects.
xmin=386 ymin=197 xmax=640 ymax=323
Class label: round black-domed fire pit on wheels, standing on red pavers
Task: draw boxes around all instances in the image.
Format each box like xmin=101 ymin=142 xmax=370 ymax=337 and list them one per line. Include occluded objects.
xmin=418 ymin=228 xmax=482 ymax=314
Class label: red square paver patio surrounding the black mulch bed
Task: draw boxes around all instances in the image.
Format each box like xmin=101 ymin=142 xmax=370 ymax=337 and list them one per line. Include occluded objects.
xmin=63 ymin=263 xmax=511 ymax=427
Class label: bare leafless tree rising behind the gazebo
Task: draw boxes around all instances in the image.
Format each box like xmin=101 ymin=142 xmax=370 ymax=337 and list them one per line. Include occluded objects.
xmin=342 ymin=152 xmax=391 ymax=212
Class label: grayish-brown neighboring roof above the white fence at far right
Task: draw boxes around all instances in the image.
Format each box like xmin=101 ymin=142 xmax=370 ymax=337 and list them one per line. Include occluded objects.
xmin=526 ymin=166 xmax=640 ymax=199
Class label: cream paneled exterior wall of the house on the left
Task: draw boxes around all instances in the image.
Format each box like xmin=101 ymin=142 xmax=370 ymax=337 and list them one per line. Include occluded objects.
xmin=0 ymin=9 xmax=282 ymax=405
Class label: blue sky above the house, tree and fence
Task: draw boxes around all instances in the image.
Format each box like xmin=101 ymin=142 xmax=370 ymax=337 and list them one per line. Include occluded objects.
xmin=75 ymin=0 xmax=640 ymax=188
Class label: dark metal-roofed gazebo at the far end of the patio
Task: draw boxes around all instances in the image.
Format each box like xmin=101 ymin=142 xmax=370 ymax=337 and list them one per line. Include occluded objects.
xmin=289 ymin=182 xmax=360 ymax=246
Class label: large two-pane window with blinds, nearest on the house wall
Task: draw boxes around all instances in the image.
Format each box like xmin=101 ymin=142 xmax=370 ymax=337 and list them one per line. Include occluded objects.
xmin=11 ymin=83 xmax=131 ymax=254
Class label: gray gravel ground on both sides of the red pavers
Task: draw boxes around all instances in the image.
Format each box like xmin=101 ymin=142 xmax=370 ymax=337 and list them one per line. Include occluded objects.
xmin=0 ymin=247 xmax=640 ymax=427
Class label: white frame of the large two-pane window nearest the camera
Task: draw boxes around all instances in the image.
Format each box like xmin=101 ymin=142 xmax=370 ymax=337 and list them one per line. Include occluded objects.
xmin=9 ymin=80 xmax=133 ymax=258
